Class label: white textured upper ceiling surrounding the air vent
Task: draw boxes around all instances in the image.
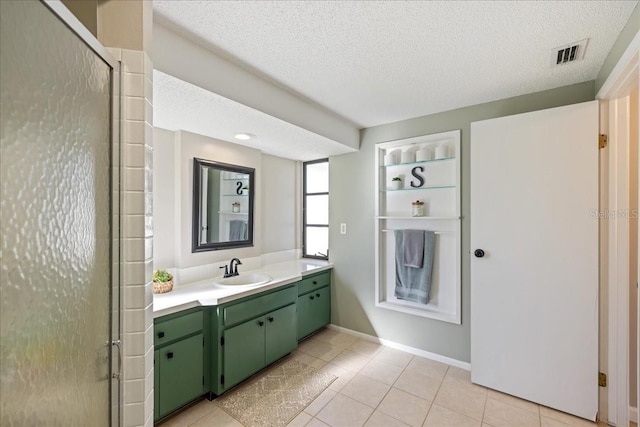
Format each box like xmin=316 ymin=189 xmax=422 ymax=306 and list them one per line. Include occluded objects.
xmin=154 ymin=0 xmax=638 ymax=127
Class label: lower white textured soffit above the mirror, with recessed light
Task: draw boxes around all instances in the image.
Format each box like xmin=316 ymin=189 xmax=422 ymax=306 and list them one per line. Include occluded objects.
xmin=153 ymin=71 xmax=353 ymax=161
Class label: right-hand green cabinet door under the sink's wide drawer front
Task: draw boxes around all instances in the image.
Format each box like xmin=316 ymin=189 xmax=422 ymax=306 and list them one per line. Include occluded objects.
xmin=265 ymin=304 xmax=298 ymax=365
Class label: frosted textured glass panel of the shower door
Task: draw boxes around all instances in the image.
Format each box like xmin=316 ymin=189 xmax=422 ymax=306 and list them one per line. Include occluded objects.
xmin=0 ymin=1 xmax=118 ymax=426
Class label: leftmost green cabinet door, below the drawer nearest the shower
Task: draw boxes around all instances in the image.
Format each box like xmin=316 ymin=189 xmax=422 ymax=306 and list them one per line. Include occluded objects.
xmin=156 ymin=334 xmax=204 ymax=417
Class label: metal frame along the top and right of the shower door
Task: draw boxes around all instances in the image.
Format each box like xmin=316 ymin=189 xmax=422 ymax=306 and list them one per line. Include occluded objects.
xmin=40 ymin=0 xmax=123 ymax=427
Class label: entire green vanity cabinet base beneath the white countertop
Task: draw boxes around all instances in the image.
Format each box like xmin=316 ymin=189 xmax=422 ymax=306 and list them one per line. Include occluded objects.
xmin=154 ymin=270 xmax=331 ymax=414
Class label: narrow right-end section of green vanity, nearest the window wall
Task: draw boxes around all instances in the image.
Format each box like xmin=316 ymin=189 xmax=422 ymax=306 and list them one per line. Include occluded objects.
xmin=298 ymin=270 xmax=331 ymax=340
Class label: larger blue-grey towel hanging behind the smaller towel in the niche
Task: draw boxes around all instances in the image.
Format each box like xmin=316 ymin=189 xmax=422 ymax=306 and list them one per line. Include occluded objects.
xmin=394 ymin=230 xmax=436 ymax=304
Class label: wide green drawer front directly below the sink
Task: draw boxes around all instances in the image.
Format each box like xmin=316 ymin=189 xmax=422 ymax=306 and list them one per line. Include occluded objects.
xmin=222 ymin=286 xmax=298 ymax=326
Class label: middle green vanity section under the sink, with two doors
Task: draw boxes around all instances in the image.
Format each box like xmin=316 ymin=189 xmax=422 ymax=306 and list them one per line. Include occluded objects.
xmin=211 ymin=283 xmax=298 ymax=395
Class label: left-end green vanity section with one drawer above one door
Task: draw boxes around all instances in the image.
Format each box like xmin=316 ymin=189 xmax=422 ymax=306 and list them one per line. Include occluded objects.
xmin=154 ymin=308 xmax=206 ymax=420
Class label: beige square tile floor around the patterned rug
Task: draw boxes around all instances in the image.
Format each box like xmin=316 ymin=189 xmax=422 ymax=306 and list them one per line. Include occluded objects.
xmin=161 ymin=329 xmax=624 ymax=427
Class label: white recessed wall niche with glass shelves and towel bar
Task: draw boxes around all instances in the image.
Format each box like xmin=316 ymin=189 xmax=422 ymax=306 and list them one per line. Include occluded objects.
xmin=375 ymin=130 xmax=462 ymax=324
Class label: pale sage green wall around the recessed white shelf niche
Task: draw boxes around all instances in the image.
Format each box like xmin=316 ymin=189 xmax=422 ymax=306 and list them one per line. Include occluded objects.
xmin=329 ymin=81 xmax=595 ymax=362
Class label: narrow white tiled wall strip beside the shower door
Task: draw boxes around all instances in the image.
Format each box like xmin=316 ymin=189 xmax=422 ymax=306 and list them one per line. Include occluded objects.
xmin=109 ymin=49 xmax=153 ymax=427
